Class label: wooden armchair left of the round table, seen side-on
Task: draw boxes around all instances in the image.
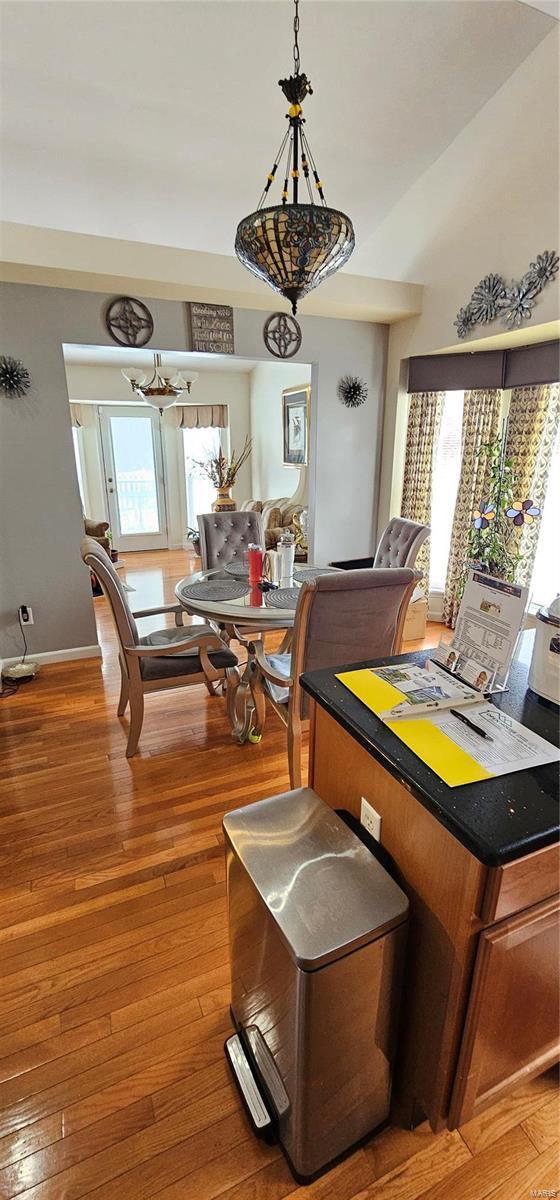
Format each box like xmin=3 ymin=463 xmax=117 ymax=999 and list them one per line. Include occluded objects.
xmin=80 ymin=538 xmax=237 ymax=758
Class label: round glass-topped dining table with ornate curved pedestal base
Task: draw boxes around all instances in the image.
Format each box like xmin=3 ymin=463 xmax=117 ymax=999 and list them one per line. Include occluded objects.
xmin=175 ymin=564 xmax=336 ymax=743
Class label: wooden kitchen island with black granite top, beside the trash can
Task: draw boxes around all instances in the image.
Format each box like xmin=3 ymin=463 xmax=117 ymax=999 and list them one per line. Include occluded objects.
xmin=302 ymin=632 xmax=560 ymax=1129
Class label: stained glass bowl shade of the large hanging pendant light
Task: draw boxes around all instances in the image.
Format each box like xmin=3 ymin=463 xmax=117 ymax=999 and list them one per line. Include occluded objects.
xmin=235 ymin=204 xmax=354 ymax=313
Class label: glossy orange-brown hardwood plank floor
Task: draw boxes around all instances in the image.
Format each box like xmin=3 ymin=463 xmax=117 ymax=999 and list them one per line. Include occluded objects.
xmin=0 ymin=551 xmax=559 ymax=1200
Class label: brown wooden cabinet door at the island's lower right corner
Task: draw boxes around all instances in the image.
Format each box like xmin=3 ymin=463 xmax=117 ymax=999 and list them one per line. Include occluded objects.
xmin=450 ymin=896 xmax=560 ymax=1129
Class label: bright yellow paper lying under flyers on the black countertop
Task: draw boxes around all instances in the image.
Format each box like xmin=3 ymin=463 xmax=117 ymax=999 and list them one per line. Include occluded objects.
xmin=337 ymin=667 xmax=494 ymax=787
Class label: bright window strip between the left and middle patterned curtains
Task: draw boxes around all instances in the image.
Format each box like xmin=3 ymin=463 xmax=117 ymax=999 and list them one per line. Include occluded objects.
xmin=429 ymin=391 xmax=464 ymax=592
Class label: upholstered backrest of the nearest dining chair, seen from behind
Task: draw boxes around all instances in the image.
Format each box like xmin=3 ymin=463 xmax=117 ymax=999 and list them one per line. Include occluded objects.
xmin=291 ymin=566 xmax=417 ymax=712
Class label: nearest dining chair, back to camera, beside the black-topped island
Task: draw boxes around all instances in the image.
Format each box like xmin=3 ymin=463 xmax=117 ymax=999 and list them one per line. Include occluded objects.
xmin=248 ymin=568 xmax=419 ymax=787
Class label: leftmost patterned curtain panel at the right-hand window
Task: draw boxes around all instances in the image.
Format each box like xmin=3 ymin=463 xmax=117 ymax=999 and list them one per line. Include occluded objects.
xmin=401 ymin=391 xmax=445 ymax=578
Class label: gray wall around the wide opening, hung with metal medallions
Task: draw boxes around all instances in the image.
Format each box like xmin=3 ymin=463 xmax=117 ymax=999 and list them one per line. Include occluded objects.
xmin=0 ymin=283 xmax=387 ymax=658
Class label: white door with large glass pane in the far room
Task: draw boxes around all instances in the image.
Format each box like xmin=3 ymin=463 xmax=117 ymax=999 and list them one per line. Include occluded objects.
xmin=98 ymin=404 xmax=168 ymax=551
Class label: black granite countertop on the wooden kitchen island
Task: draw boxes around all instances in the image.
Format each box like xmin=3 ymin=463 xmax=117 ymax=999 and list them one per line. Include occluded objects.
xmin=301 ymin=631 xmax=560 ymax=866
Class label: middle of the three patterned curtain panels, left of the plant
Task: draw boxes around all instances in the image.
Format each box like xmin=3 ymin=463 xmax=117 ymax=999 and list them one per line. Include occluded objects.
xmin=444 ymin=390 xmax=501 ymax=629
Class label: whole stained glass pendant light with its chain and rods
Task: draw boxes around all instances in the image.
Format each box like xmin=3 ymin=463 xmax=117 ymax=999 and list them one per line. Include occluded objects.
xmin=235 ymin=0 xmax=354 ymax=313
